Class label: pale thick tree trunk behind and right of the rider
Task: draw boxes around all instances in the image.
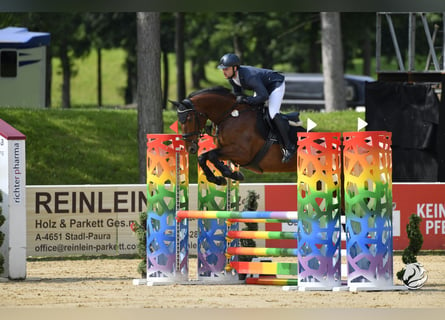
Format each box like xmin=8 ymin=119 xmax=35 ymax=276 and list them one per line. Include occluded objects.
xmin=321 ymin=12 xmax=346 ymax=112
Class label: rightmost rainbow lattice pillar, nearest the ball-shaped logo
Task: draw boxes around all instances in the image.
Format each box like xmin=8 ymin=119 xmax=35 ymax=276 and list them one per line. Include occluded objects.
xmin=343 ymin=131 xmax=393 ymax=289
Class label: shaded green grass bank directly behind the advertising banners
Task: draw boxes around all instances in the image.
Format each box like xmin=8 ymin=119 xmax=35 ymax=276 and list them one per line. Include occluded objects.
xmin=0 ymin=108 xmax=364 ymax=185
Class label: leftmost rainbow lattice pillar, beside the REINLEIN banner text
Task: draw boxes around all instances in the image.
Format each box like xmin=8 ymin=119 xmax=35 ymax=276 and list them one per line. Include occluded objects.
xmin=147 ymin=134 xmax=189 ymax=285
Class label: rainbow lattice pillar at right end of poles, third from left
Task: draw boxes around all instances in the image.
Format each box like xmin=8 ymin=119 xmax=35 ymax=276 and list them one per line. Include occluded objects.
xmin=297 ymin=132 xmax=341 ymax=290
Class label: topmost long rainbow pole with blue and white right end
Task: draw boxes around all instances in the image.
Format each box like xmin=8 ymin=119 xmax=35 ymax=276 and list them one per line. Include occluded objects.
xmin=176 ymin=210 xmax=298 ymax=222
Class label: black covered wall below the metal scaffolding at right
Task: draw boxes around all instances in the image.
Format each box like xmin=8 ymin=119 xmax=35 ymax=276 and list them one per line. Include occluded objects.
xmin=366 ymin=81 xmax=440 ymax=182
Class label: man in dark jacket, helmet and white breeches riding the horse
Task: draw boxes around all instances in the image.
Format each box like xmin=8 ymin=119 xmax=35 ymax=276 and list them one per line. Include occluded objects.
xmin=218 ymin=53 xmax=296 ymax=163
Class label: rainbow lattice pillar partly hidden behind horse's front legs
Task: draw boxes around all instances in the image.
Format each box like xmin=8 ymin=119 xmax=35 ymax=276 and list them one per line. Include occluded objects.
xmin=197 ymin=135 xmax=239 ymax=282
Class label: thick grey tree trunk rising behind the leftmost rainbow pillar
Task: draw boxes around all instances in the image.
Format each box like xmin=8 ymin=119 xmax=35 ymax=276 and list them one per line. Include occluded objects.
xmin=136 ymin=12 xmax=164 ymax=183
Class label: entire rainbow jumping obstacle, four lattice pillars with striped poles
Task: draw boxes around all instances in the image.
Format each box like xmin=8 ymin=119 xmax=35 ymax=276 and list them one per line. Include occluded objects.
xmin=143 ymin=132 xmax=398 ymax=291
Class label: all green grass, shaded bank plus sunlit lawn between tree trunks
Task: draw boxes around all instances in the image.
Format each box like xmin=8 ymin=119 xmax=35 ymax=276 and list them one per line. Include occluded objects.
xmin=0 ymin=50 xmax=364 ymax=185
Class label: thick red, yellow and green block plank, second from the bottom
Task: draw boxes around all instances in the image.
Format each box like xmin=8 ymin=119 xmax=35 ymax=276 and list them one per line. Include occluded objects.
xmin=230 ymin=261 xmax=298 ymax=275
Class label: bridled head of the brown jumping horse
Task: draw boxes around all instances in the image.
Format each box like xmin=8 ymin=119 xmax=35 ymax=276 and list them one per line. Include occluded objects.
xmin=170 ymin=99 xmax=207 ymax=154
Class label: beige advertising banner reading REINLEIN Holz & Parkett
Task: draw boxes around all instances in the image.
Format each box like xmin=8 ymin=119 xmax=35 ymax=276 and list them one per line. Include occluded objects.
xmin=27 ymin=185 xmax=147 ymax=257
